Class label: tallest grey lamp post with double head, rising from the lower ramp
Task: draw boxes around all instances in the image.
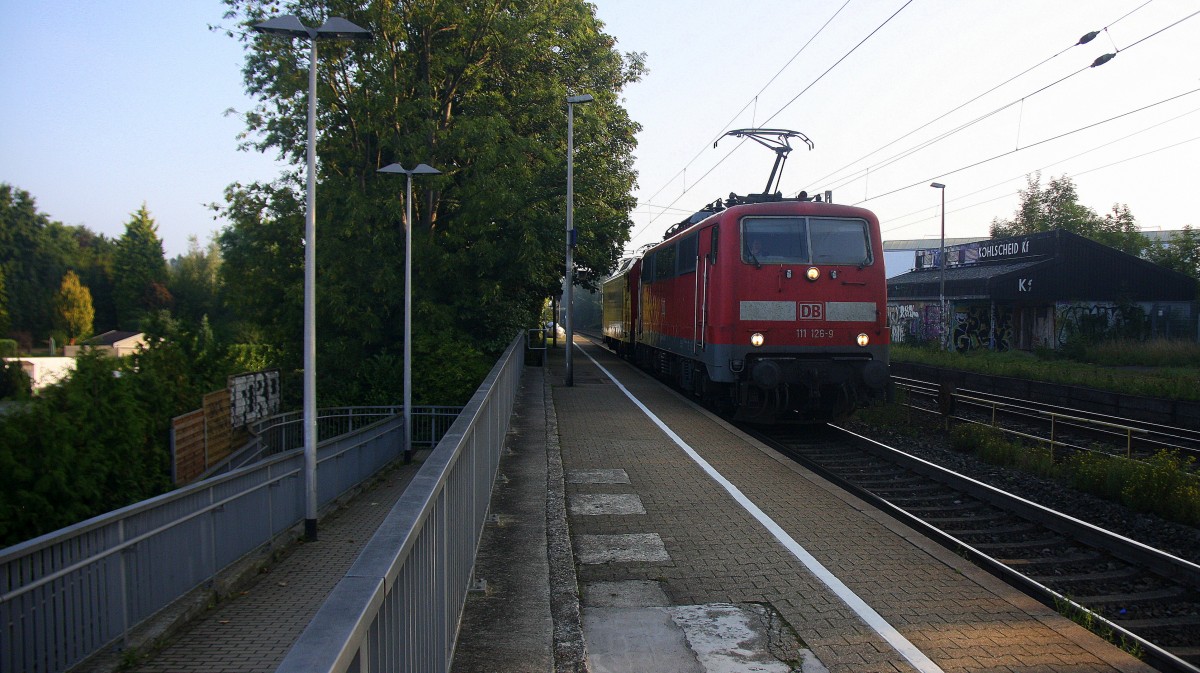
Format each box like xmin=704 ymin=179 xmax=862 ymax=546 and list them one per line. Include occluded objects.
xmin=251 ymin=14 xmax=371 ymax=540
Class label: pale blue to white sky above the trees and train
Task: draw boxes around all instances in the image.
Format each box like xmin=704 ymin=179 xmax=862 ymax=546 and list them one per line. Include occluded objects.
xmin=0 ymin=0 xmax=1200 ymax=257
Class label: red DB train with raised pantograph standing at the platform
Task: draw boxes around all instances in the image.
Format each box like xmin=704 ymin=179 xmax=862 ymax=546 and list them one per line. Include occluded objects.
xmin=601 ymin=128 xmax=890 ymax=423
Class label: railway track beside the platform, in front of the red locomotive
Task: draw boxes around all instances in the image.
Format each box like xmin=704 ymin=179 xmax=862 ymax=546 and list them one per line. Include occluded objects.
xmin=748 ymin=426 xmax=1200 ymax=673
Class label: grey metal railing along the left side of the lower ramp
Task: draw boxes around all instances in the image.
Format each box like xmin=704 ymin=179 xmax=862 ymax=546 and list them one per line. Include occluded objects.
xmin=0 ymin=408 xmax=453 ymax=673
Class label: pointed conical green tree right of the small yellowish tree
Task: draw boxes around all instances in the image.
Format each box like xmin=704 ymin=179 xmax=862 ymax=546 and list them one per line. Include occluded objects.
xmin=113 ymin=204 xmax=170 ymax=329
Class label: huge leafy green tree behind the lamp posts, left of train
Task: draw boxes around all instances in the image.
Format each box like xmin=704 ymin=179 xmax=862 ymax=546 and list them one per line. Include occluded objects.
xmin=221 ymin=0 xmax=642 ymax=402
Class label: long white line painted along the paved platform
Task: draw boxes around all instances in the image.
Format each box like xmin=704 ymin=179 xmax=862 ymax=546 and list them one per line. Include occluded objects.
xmin=580 ymin=348 xmax=944 ymax=673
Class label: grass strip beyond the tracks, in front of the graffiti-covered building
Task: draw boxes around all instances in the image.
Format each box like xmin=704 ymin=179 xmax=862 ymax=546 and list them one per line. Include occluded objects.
xmin=892 ymin=341 xmax=1200 ymax=402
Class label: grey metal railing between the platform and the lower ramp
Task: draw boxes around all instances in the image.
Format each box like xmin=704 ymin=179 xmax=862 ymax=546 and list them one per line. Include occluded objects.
xmin=276 ymin=335 xmax=524 ymax=673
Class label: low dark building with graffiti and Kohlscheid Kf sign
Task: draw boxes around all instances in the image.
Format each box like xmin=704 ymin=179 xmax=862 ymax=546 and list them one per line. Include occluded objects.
xmin=888 ymin=229 xmax=1200 ymax=350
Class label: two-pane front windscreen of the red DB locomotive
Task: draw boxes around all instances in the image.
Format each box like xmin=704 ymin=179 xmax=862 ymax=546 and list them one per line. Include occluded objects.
xmin=742 ymin=217 xmax=874 ymax=265
